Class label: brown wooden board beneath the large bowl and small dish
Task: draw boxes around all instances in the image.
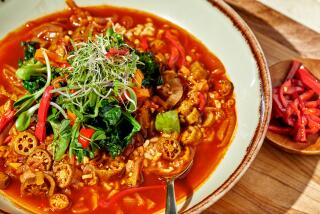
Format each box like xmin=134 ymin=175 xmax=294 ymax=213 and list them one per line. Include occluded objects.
xmin=204 ymin=0 xmax=320 ymax=214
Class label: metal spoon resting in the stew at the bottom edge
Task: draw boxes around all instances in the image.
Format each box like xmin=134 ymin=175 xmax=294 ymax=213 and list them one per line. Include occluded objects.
xmin=163 ymin=158 xmax=193 ymax=214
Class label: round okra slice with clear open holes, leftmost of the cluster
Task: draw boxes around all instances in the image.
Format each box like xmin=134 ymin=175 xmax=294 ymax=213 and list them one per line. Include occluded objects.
xmin=13 ymin=131 xmax=38 ymax=155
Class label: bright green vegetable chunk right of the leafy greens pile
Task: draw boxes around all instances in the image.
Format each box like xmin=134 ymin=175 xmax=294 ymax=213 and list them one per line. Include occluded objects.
xmin=155 ymin=110 xmax=180 ymax=133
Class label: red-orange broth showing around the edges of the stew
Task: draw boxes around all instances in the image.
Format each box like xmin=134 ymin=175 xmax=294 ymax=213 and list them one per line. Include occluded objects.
xmin=0 ymin=3 xmax=235 ymax=213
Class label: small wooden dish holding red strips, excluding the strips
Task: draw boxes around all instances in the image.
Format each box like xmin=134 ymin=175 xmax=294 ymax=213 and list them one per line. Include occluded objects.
xmin=267 ymin=58 xmax=320 ymax=155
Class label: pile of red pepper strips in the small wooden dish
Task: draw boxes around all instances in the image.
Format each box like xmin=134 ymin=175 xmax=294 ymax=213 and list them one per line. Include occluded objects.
xmin=268 ymin=60 xmax=320 ymax=143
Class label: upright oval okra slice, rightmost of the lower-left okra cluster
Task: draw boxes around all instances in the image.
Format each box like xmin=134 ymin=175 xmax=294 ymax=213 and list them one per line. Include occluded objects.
xmin=53 ymin=162 xmax=73 ymax=188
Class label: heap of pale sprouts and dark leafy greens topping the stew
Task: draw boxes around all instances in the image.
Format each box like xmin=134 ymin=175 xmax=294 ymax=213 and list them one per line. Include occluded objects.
xmin=50 ymin=28 xmax=140 ymax=161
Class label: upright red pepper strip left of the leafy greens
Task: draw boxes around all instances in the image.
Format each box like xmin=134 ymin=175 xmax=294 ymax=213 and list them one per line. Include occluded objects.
xmin=35 ymin=86 xmax=54 ymax=143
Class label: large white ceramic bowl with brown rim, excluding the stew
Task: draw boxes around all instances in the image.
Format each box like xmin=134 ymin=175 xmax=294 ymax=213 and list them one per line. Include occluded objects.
xmin=0 ymin=0 xmax=271 ymax=213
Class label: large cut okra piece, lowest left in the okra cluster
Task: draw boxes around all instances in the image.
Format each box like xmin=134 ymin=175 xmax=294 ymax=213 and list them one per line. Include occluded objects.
xmin=20 ymin=172 xmax=56 ymax=196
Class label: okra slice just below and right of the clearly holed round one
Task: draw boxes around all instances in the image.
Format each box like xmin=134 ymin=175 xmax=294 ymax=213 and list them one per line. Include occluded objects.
xmin=27 ymin=149 xmax=52 ymax=171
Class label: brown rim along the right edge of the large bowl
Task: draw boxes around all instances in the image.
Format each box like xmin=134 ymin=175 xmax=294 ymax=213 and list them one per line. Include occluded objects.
xmin=182 ymin=0 xmax=272 ymax=213
